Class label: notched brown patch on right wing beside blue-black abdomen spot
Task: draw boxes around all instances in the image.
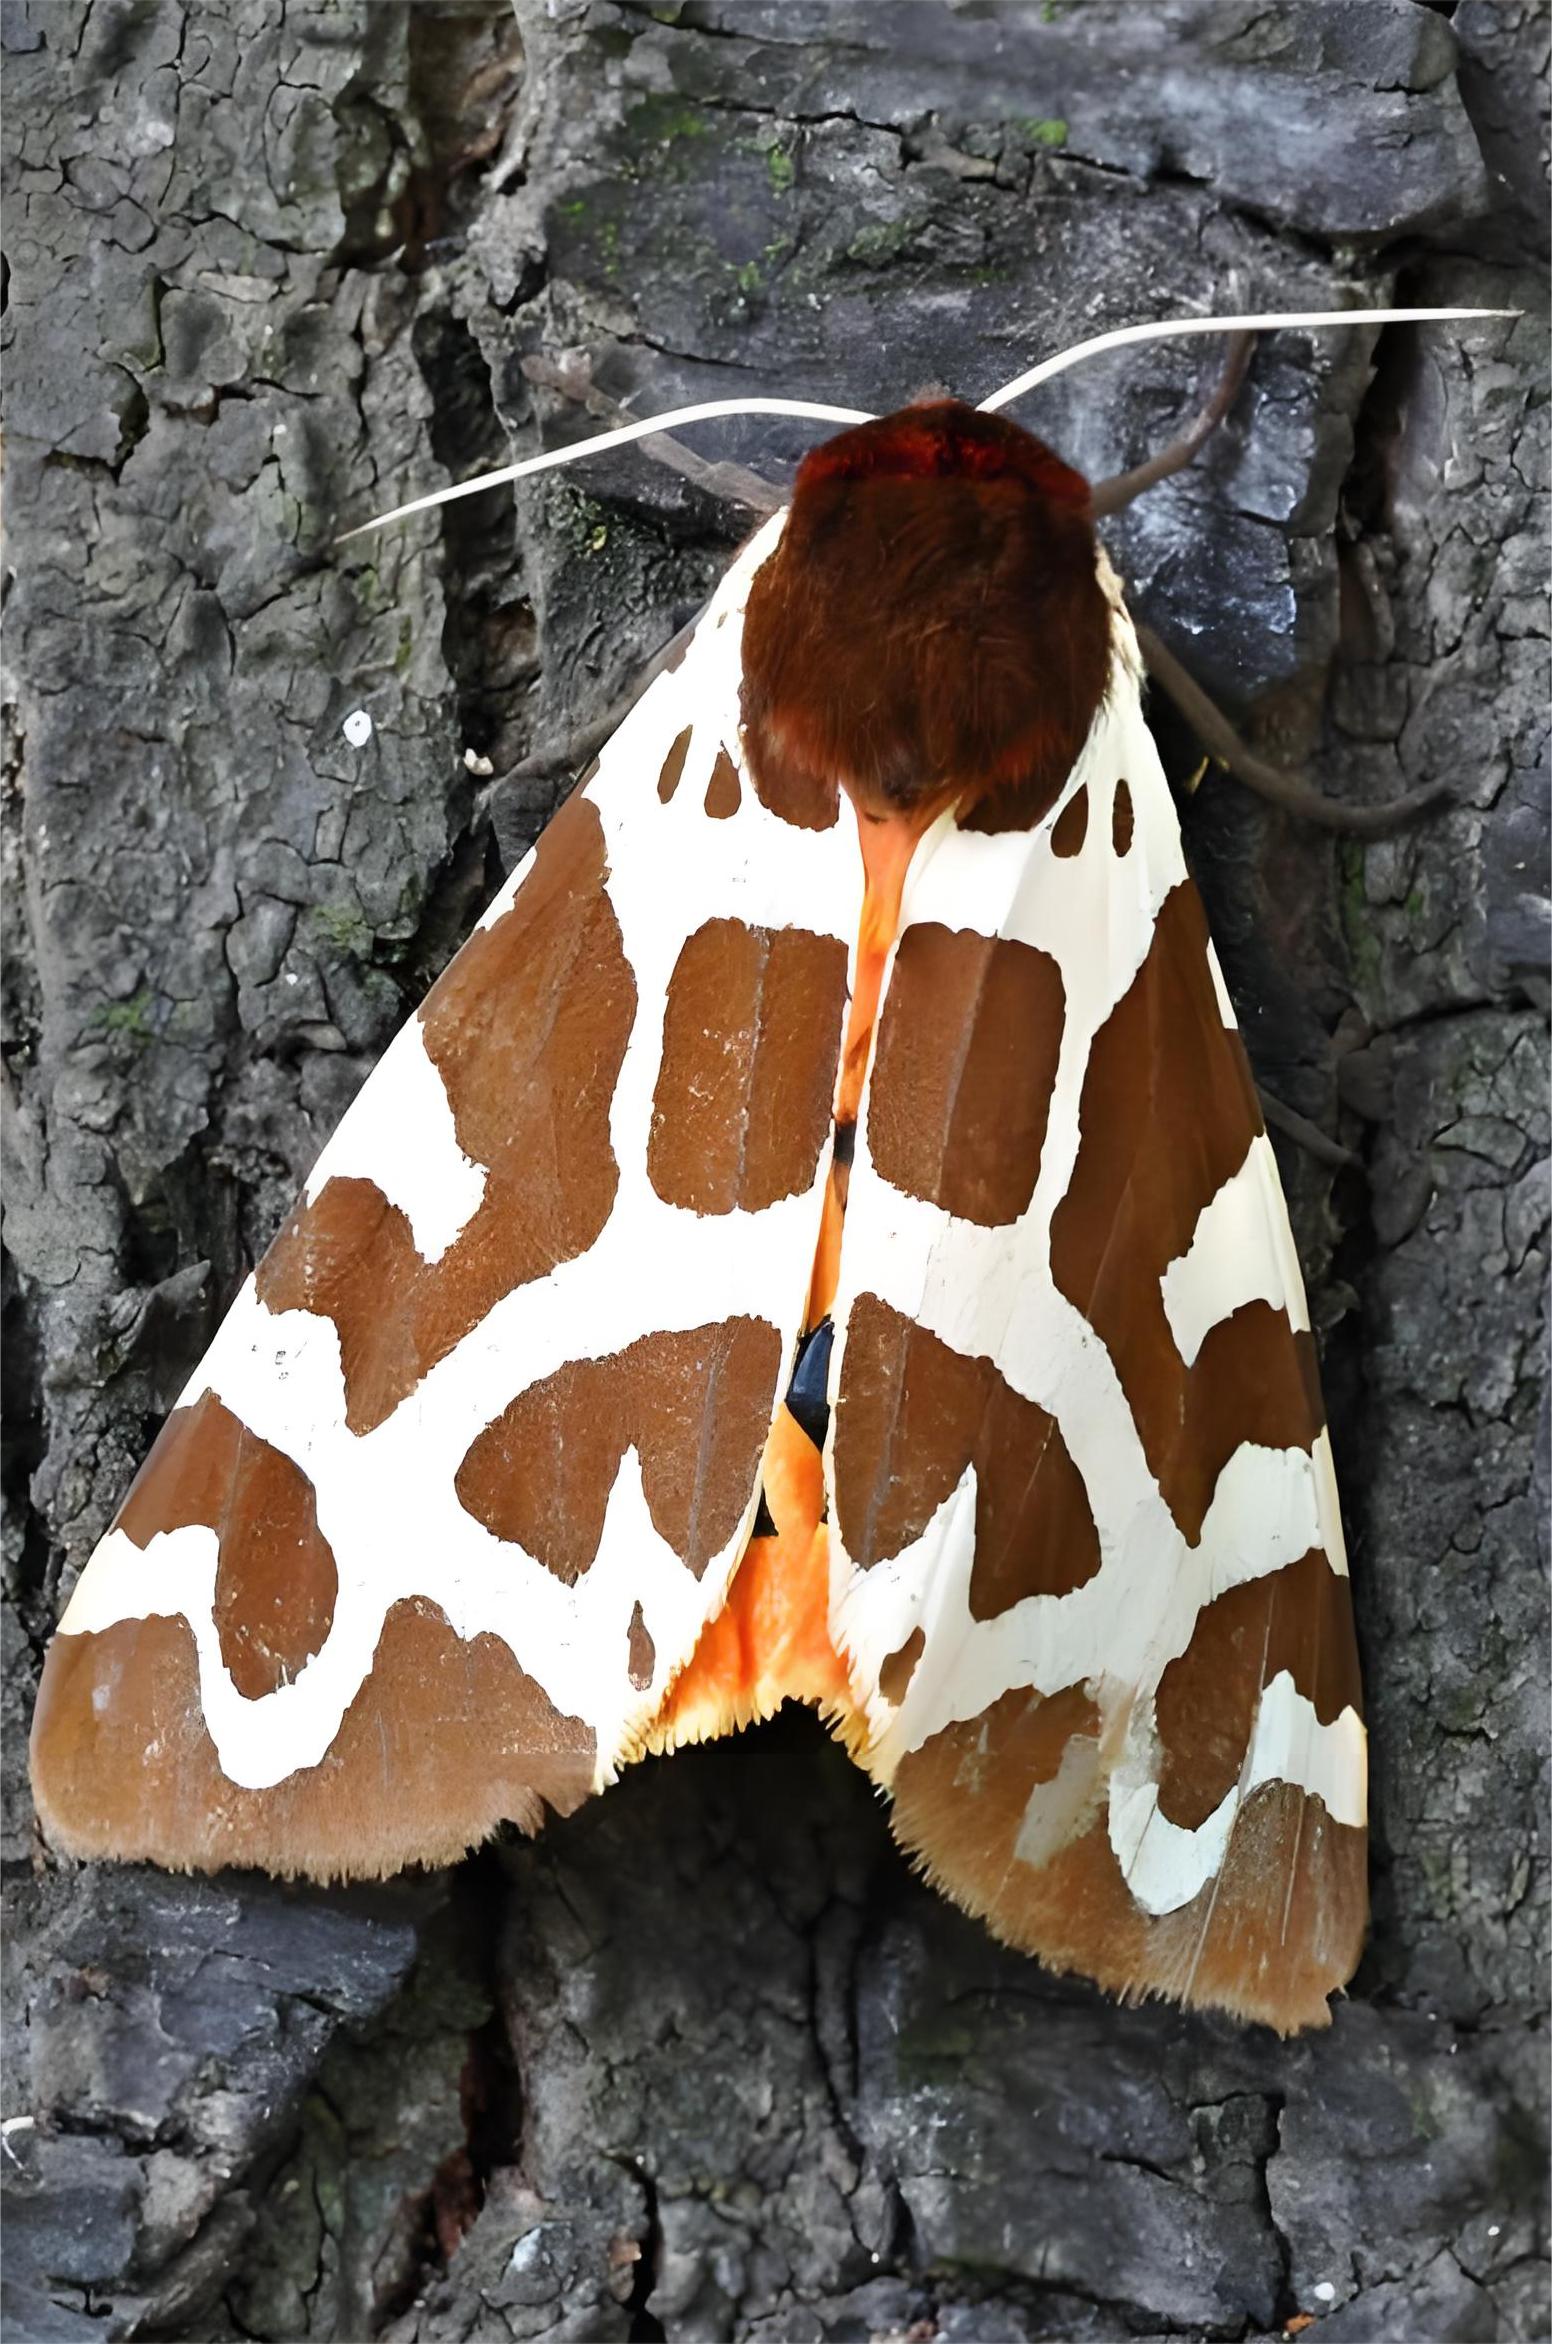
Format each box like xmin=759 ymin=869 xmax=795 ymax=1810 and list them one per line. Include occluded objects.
xmin=835 ymin=1294 xmax=1100 ymax=1620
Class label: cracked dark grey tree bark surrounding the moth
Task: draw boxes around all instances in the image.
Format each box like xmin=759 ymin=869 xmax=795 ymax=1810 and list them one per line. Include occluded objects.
xmin=0 ymin=0 xmax=1547 ymax=2344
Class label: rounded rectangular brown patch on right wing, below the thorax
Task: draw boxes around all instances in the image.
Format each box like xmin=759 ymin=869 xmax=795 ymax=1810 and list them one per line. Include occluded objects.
xmin=867 ymin=921 xmax=1064 ymax=1228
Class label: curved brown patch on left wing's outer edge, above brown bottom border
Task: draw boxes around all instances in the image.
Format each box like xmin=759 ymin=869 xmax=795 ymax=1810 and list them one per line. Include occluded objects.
xmin=117 ymin=1392 xmax=340 ymax=1702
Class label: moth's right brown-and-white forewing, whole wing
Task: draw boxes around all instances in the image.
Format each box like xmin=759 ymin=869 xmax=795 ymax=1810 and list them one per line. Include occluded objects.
xmin=828 ymin=590 xmax=1367 ymax=2030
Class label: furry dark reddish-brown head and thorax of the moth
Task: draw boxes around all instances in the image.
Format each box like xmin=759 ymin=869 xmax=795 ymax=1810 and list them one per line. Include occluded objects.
xmin=743 ymin=401 xmax=1111 ymax=830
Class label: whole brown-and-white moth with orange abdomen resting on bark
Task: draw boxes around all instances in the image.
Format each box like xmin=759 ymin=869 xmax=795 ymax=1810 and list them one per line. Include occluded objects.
xmin=33 ymin=319 xmax=1509 ymax=2032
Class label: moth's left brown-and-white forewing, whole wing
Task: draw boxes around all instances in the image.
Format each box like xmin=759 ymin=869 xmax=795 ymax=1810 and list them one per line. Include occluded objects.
xmin=33 ymin=503 xmax=860 ymax=1875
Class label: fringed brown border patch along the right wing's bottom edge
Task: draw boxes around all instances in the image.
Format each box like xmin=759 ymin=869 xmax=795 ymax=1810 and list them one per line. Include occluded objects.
xmin=893 ymin=1685 xmax=1367 ymax=2035
